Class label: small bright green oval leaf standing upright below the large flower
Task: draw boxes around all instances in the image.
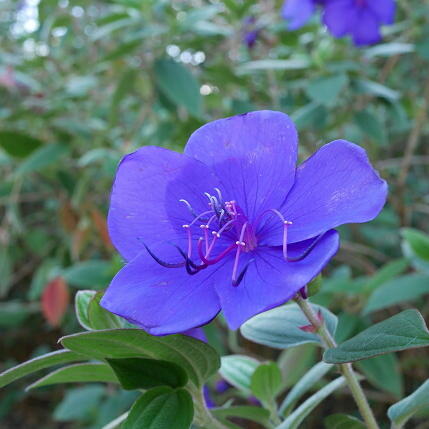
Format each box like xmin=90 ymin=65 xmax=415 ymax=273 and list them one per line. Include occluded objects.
xmin=250 ymin=362 xmax=282 ymax=404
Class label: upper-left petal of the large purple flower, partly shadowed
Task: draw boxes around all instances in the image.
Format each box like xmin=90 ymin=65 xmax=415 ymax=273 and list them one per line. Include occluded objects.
xmin=108 ymin=146 xmax=219 ymax=260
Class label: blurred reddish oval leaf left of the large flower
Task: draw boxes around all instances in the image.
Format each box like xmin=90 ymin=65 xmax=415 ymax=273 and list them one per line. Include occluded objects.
xmin=42 ymin=277 xmax=70 ymax=326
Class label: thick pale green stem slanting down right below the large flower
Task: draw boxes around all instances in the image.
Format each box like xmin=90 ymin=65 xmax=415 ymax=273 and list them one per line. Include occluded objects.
xmin=295 ymin=293 xmax=379 ymax=429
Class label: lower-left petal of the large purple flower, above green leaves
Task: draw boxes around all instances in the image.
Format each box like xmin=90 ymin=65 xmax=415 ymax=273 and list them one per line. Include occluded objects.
xmin=101 ymin=244 xmax=230 ymax=335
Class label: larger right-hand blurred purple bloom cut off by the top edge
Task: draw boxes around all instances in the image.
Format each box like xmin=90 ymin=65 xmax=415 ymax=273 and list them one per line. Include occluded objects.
xmin=323 ymin=0 xmax=396 ymax=46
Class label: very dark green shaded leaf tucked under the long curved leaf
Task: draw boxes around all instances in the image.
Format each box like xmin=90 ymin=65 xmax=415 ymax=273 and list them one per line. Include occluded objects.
xmin=106 ymin=358 xmax=188 ymax=390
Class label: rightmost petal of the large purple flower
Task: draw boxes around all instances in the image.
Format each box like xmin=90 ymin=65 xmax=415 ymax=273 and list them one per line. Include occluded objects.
xmin=264 ymin=140 xmax=387 ymax=245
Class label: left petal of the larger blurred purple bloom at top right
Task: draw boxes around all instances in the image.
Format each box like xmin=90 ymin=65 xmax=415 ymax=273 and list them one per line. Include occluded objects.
xmin=323 ymin=0 xmax=360 ymax=37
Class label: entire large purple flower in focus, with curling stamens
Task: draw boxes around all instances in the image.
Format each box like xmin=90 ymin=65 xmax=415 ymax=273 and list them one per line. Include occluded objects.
xmin=102 ymin=111 xmax=387 ymax=335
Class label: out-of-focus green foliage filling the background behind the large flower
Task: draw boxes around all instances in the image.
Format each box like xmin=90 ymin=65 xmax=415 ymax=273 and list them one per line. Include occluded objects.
xmin=0 ymin=0 xmax=429 ymax=429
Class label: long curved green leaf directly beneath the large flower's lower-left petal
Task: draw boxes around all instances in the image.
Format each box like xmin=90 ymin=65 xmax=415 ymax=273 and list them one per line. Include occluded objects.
xmin=60 ymin=329 xmax=220 ymax=387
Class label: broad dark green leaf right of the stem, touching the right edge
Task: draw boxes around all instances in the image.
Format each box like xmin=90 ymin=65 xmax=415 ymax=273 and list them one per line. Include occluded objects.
xmin=323 ymin=310 xmax=429 ymax=363
